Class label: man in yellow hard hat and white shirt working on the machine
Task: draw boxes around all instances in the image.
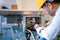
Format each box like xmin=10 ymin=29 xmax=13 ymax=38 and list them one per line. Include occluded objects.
xmin=34 ymin=0 xmax=60 ymax=40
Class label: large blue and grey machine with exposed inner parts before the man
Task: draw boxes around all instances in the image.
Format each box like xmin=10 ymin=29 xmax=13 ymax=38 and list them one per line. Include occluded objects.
xmin=0 ymin=11 xmax=54 ymax=40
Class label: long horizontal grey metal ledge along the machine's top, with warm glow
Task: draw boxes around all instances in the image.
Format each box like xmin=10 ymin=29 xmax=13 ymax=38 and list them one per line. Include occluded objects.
xmin=0 ymin=10 xmax=40 ymax=16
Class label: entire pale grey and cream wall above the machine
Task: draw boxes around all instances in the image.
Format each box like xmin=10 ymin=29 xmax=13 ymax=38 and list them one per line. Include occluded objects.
xmin=0 ymin=0 xmax=38 ymax=11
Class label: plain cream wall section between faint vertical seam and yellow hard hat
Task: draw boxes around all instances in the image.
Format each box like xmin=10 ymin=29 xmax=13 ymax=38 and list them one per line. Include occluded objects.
xmin=22 ymin=0 xmax=38 ymax=11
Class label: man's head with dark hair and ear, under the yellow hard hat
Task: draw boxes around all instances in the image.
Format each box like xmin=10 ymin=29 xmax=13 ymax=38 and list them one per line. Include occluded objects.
xmin=36 ymin=0 xmax=60 ymax=15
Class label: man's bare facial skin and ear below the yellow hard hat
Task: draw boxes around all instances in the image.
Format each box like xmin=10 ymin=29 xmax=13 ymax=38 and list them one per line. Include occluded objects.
xmin=43 ymin=3 xmax=58 ymax=16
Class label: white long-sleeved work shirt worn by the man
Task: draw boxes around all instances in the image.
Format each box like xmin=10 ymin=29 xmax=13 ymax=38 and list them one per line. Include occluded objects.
xmin=36 ymin=7 xmax=60 ymax=40
